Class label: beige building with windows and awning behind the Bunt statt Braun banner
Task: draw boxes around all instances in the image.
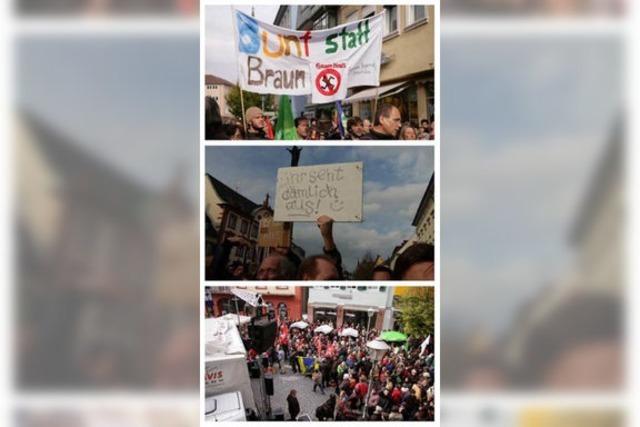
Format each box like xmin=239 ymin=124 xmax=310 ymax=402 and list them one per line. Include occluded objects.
xmin=274 ymin=5 xmax=435 ymax=126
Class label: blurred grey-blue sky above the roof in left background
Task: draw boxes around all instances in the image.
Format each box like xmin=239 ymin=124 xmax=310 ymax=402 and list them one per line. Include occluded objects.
xmin=15 ymin=34 xmax=200 ymax=197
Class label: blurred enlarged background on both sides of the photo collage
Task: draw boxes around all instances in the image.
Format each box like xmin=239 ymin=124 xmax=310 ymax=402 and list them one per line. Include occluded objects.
xmin=8 ymin=0 xmax=631 ymax=426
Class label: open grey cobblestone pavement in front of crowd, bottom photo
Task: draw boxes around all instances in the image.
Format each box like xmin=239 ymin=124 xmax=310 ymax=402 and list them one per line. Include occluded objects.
xmin=251 ymin=364 xmax=331 ymax=421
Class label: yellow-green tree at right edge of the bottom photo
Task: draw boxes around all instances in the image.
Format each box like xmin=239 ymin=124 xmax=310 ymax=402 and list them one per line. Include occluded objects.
xmin=397 ymin=287 xmax=434 ymax=337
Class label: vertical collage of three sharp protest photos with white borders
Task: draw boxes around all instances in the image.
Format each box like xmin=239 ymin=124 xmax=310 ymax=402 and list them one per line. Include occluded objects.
xmin=201 ymin=2 xmax=440 ymax=424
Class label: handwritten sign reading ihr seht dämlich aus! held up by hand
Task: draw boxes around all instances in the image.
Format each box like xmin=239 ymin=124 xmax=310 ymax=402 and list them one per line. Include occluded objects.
xmin=274 ymin=162 xmax=362 ymax=222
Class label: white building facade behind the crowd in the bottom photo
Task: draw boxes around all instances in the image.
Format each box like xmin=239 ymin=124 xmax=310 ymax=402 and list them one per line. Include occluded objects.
xmin=307 ymin=286 xmax=394 ymax=331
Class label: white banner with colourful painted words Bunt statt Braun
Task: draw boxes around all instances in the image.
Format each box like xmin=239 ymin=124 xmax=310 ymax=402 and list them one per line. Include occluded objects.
xmin=234 ymin=10 xmax=384 ymax=104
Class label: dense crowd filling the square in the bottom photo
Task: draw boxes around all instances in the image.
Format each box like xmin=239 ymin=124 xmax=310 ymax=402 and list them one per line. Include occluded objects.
xmin=248 ymin=322 xmax=435 ymax=421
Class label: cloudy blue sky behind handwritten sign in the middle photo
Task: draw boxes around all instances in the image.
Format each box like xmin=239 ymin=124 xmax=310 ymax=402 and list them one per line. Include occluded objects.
xmin=205 ymin=147 xmax=433 ymax=270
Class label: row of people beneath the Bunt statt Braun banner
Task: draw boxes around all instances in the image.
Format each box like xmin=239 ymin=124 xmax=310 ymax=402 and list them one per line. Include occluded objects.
xmin=205 ymin=97 xmax=435 ymax=140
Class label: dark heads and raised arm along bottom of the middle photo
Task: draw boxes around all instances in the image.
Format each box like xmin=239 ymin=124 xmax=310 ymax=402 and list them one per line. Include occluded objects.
xmin=206 ymin=215 xmax=434 ymax=280
